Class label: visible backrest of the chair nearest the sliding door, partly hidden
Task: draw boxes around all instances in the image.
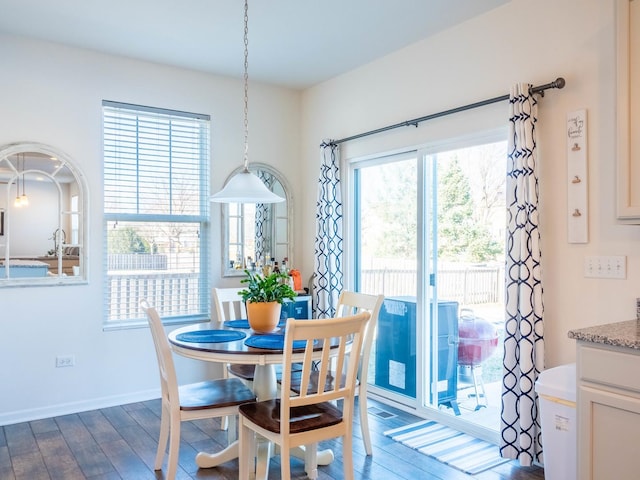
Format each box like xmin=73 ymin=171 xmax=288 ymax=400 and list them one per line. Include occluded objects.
xmin=336 ymin=290 xmax=384 ymax=385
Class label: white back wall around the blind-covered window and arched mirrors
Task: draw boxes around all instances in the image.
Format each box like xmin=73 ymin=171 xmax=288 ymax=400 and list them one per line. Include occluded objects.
xmin=0 ymin=36 xmax=302 ymax=425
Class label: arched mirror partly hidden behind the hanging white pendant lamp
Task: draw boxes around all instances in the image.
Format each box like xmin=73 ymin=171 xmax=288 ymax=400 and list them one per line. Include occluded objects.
xmin=222 ymin=163 xmax=293 ymax=277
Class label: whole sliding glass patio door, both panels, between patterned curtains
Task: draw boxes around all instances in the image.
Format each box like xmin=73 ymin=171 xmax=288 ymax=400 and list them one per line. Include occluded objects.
xmin=349 ymin=133 xmax=506 ymax=437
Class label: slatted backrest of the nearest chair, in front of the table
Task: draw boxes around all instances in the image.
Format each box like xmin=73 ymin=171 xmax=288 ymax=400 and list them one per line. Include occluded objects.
xmin=280 ymin=312 xmax=370 ymax=435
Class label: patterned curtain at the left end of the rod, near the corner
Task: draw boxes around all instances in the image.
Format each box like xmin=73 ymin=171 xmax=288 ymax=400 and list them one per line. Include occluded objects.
xmin=313 ymin=142 xmax=343 ymax=318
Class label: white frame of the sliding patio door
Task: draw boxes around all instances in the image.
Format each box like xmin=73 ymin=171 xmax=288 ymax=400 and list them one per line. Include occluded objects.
xmin=343 ymin=128 xmax=507 ymax=443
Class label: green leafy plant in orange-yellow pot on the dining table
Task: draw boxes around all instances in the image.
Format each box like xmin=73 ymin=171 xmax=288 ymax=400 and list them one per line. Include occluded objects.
xmin=239 ymin=270 xmax=296 ymax=333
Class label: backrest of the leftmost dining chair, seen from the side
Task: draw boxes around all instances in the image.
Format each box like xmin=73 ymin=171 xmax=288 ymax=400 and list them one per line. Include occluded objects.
xmin=140 ymin=300 xmax=180 ymax=407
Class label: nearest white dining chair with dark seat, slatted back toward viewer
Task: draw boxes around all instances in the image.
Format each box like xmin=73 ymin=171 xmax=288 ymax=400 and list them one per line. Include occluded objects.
xmin=238 ymin=312 xmax=370 ymax=480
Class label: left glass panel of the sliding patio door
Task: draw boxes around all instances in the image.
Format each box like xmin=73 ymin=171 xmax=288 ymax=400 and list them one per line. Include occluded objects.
xmin=353 ymin=152 xmax=422 ymax=405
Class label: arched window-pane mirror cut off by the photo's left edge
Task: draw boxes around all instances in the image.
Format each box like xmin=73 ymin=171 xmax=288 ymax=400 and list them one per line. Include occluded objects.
xmin=0 ymin=143 xmax=87 ymax=286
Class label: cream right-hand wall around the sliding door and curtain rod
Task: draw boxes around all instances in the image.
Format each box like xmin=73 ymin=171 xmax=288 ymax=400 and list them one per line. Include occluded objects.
xmin=301 ymin=0 xmax=640 ymax=366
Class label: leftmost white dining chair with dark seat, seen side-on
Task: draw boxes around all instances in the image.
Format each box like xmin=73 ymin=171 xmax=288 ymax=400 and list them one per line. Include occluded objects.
xmin=140 ymin=300 xmax=256 ymax=480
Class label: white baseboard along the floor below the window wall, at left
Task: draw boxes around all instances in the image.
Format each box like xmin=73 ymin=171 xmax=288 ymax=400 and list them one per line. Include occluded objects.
xmin=0 ymin=389 xmax=160 ymax=426
